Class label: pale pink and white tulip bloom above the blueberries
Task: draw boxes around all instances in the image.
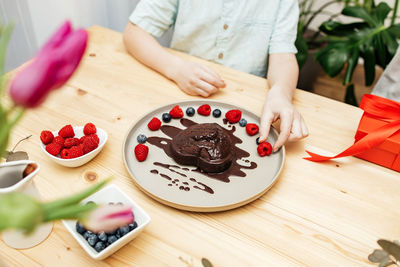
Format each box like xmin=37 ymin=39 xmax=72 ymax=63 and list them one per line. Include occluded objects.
xmin=82 ymin=205 xmax=134 ymax=233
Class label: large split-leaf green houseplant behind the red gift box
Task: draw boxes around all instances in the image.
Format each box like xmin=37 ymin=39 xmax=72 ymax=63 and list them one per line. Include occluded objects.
xmin=304 ymin=0 xmax=400 ymax=105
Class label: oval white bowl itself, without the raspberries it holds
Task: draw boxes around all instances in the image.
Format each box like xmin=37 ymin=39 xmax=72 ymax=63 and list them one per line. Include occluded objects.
xmin=40 ymin=126 xmax=108 ymax=167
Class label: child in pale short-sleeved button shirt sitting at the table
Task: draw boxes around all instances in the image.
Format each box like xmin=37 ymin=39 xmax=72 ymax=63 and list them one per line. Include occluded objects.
xmin=124 ymin=0 xmax=308 ymax=151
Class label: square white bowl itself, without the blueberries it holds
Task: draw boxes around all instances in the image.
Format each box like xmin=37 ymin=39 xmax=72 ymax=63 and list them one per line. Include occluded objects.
xmin=62 ymin=184 xmax=151 ymax=260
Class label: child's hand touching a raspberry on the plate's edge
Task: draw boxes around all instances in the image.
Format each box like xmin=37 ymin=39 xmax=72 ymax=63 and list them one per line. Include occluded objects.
xmin=260 ymin=88 xmax=308 ymax=152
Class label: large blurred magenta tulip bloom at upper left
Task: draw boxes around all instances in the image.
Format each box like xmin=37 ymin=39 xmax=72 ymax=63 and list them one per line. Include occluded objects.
xmin=10 ymin=21 xmax=88 ymax=108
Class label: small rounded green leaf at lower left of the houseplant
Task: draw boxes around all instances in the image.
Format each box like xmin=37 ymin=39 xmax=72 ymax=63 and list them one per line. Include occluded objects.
xmin=315 ymin=42 xmax=348 ymax=77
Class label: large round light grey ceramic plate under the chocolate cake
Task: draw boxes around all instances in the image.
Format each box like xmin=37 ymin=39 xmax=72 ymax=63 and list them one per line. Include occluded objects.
xmin=123 ymin=100 xmax=285 ymax=212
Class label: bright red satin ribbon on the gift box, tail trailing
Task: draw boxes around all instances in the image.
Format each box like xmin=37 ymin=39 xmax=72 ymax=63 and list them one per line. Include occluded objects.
xmin=304 ymin=94 xmax=400 ymax=162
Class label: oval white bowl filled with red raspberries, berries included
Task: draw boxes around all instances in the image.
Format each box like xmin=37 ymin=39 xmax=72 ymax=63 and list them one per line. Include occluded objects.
xmin=40 ymin=122 xmax=108 ymax=167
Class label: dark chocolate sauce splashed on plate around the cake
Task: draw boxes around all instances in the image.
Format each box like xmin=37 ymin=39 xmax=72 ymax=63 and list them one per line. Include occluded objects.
xmin=147 ymin=118 xmax=257 ymax=184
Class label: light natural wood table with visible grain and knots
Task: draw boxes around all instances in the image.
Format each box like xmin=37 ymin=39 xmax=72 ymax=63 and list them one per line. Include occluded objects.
xmin=0 ymin=26 xmax=400 ymax=266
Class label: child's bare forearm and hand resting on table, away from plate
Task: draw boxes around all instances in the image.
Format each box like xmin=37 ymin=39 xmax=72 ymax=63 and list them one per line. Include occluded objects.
xmin=124 ymin=23 xmax=225 ymax=97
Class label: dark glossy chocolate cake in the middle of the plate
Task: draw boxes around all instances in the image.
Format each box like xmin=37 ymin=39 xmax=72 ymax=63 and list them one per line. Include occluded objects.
xmin=170 ymin=123 xmax=234 ymax=173
